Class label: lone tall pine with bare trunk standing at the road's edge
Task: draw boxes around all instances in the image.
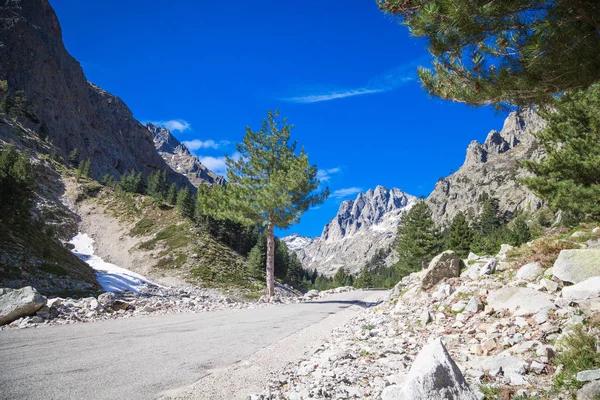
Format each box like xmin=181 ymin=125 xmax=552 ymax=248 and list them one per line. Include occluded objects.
xmin=201 ymin=111 xmax=329 ymax=299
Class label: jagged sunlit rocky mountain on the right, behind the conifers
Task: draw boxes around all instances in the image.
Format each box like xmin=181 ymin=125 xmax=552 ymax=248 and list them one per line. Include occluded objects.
xmin=427 ymin=110 xmax=544 ymax=225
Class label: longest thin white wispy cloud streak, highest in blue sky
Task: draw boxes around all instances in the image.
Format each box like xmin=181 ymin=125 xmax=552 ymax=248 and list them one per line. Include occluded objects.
xmin=281 ymin=59 xmax=423 ymax=103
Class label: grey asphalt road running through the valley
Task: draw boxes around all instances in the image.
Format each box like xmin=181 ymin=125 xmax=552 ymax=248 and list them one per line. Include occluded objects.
xmin=0 ymin=291 xmax=382 ymax=400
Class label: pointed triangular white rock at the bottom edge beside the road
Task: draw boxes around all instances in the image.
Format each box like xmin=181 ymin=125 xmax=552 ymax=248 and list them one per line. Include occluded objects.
xmin=394 ymin=339 xmax=477 ymax=400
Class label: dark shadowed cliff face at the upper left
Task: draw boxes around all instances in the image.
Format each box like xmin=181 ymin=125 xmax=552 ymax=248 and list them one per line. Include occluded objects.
xmin=0 ymin=0 xmax=187 ymax=184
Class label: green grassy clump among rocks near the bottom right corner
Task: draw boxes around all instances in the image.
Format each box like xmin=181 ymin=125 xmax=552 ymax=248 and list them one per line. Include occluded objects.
xmin=553 ymin=325 xmax=600 ymax=391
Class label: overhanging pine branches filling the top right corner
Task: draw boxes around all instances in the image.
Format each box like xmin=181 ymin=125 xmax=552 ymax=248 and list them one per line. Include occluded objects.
xmin=378 ymin=0 xmax=600 ymax=105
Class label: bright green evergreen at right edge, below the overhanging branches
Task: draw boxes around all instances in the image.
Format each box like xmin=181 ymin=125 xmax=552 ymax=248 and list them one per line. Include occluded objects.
xmin=523 ymin=84 xmax=600 ymax=221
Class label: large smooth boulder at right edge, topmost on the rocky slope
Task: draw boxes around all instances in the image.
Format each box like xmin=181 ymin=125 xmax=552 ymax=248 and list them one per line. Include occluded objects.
xmin=553 ymin=249 xmax=600 ymax=283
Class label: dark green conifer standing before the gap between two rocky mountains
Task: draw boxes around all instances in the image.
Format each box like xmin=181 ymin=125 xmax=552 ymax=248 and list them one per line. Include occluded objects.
xmin=395 ymin=199 xmax=441 ymax=276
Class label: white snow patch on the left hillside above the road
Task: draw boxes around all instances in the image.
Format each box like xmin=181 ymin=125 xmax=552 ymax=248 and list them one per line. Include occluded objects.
xmin=69 ymin=232 xmax=160 ymax=293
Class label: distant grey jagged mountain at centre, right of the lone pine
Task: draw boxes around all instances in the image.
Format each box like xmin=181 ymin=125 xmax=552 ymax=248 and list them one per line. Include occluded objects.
xmin=283 ymin=186 xmax=416 ymax=276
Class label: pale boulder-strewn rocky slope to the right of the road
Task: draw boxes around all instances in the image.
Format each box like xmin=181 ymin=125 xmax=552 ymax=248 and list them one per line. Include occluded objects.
xmin=250 ymin=228 xmax=600 ymax=400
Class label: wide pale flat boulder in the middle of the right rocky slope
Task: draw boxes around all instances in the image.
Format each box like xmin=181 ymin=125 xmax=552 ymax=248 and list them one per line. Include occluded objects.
xmin=487 ymin=287 xmax=554 ymax=316
